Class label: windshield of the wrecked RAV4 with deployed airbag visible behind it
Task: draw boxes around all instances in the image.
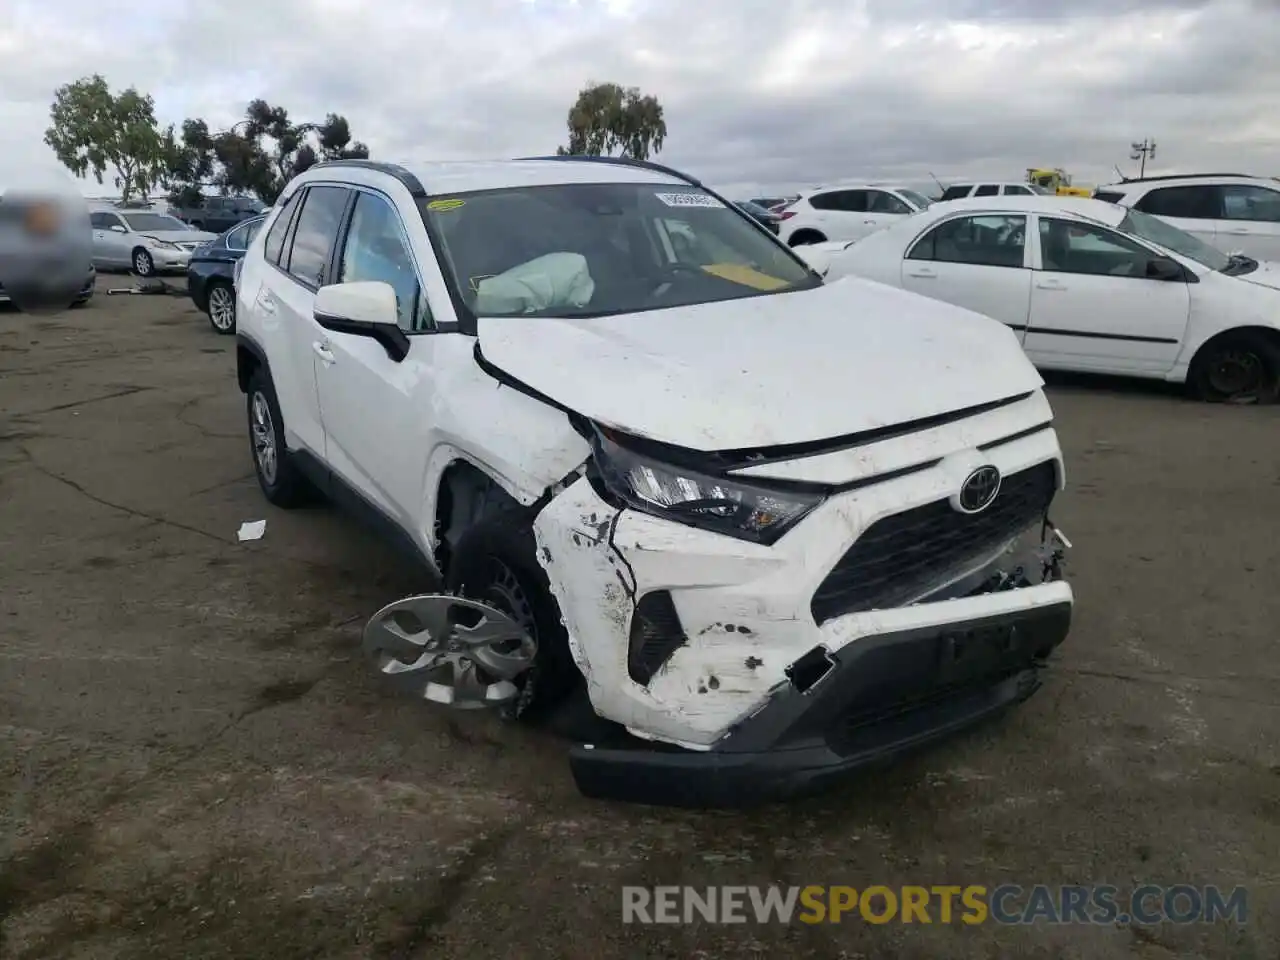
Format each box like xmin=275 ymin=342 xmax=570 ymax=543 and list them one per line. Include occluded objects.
xmin=421 ymin=183 xmax=822 ymax=323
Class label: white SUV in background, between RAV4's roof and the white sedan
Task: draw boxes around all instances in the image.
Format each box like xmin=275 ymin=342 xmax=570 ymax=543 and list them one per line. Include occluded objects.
xmin=778 ymin=184 xmax=933 ymax=247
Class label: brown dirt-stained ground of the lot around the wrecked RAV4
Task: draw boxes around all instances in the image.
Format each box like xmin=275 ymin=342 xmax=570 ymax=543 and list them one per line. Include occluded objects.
xmin=0 ymin=278 xmax=1280 ymax=960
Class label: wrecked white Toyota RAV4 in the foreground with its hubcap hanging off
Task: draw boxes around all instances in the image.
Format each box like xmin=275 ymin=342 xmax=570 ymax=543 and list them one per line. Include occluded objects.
xmin=237 ymin=157 xmax=1073 ymax=805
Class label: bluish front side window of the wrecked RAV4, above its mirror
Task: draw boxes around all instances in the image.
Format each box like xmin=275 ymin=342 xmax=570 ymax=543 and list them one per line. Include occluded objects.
xmin=337 ymin=192 xmax=431 ymax=330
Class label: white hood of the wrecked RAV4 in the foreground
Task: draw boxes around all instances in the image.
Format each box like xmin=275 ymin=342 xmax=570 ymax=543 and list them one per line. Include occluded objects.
xmin=479 ymin=278 xmax=1043 ymax=451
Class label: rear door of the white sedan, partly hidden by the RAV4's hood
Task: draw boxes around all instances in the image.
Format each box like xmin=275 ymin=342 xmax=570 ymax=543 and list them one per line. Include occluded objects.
xmin=902 ymin=214 xmax=1032 ymax=338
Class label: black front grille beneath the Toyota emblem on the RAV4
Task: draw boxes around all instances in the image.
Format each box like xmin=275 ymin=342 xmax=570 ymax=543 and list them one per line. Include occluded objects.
xmin=810 ymin=461 xmax=1057 ymax=625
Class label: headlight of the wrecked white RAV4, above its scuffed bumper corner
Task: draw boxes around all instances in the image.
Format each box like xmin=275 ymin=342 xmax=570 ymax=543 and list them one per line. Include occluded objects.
xmin=591 ymin=428 xmax=826 ymax=545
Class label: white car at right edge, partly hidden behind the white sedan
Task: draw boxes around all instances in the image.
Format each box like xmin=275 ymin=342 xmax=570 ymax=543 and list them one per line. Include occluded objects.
xmin=1093 ymin=173 xmax=1280 ymax=261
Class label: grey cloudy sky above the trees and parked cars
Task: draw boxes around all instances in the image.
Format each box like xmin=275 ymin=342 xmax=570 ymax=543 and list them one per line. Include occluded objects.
xmin=0 ymin=0 xmax=1280 ymax=198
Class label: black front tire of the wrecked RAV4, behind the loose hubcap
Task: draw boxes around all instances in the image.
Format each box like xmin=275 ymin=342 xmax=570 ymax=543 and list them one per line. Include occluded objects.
xmin=445 ymin=504 xmax=582 ymax=723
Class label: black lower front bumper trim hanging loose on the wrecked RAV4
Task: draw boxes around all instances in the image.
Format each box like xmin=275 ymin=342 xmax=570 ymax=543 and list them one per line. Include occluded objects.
xmin=570 ymin=602 xmax=1071 ymax=808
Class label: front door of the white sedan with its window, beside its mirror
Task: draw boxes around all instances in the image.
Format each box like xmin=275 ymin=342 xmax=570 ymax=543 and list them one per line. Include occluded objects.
xmin=1023 ymin=216 xmax=1190 ymax=375
